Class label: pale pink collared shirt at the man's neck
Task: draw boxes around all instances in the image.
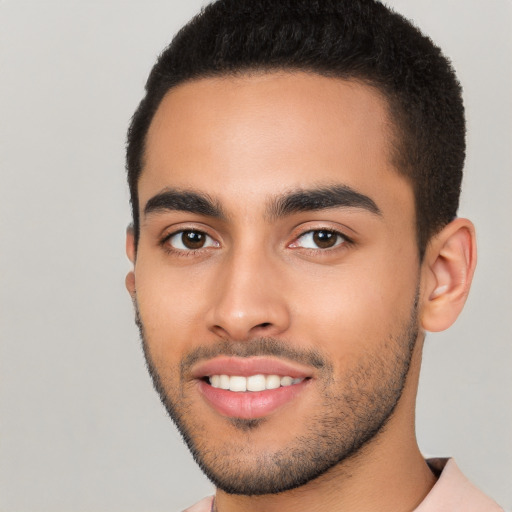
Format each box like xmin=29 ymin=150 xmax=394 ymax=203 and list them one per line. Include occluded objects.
xmin=184 ymin=459 xmax=503 ymax=512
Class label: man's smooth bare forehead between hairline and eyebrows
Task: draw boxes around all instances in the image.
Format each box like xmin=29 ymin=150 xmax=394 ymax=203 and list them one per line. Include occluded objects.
xmin=139 ymin=72 xmax=412 ymax=218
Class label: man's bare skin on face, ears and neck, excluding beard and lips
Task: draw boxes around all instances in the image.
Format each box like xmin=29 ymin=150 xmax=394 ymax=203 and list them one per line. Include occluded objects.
xmin=126 ymin=73 xmax=476 ymax=512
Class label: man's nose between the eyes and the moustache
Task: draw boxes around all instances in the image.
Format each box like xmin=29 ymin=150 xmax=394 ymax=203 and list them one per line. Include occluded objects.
xmin=206 ymin=247 xmax=290 ymax=341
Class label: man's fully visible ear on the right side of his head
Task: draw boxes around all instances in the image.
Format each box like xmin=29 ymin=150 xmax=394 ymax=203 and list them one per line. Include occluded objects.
xmin=421 ymin=219 xmax=476 ymax=332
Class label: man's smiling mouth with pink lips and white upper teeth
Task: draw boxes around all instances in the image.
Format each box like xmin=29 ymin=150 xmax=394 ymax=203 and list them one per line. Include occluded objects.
xmin=193 ymin=357 xmax=313 ymax=419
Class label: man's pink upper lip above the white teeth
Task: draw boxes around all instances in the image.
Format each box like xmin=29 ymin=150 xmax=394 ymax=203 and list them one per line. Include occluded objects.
xmin=191 ymin=356 xmax=312 ymax=379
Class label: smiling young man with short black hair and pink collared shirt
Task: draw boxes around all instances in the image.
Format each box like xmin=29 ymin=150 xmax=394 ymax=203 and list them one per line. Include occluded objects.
xmin=126 ymin=0 xmax=500 ymax=512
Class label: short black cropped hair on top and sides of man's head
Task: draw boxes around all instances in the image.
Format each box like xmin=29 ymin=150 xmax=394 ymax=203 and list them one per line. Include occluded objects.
xmin=126 ymin=0 xmax=465 ymax=258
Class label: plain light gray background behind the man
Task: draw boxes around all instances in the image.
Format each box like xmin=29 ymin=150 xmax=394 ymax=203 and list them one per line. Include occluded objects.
xmin=0 ymin=0 xmax=512 ymax=512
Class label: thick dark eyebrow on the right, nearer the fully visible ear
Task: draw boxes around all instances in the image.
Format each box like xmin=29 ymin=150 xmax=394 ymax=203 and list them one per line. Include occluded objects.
xmin=267 ymin=185 xmax=382 ymax=219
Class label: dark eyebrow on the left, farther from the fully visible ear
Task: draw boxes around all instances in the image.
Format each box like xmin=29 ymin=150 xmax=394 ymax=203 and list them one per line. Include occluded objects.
xmin=144 ymin=188 xmax=226 ymax=219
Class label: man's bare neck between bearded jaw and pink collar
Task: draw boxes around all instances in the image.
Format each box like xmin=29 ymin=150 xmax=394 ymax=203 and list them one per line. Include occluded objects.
xmin=215 ymin=342 xmax=435 ymax=512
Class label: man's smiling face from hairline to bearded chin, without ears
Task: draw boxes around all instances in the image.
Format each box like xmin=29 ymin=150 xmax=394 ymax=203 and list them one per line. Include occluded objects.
xmin=129 ymin=73 xmax=419 ymax=494
